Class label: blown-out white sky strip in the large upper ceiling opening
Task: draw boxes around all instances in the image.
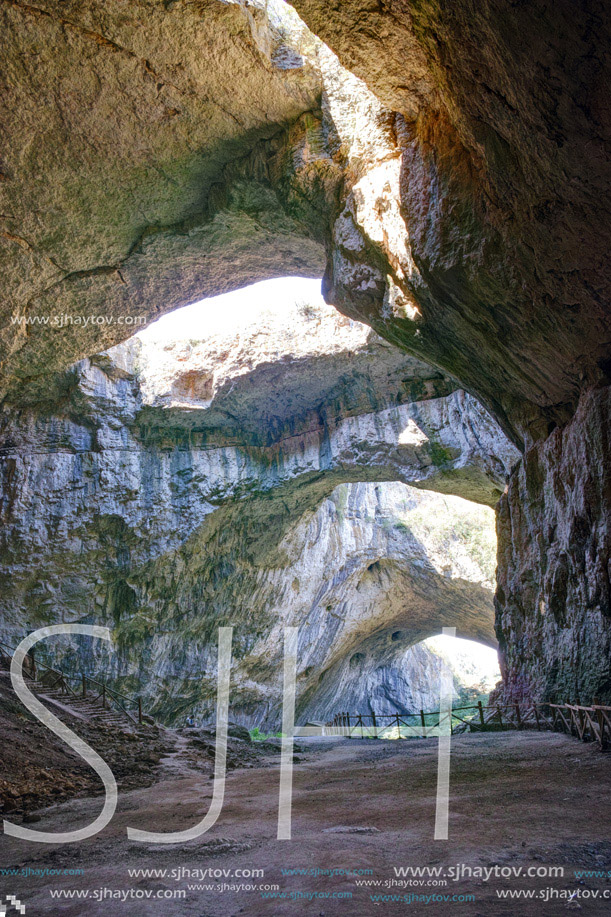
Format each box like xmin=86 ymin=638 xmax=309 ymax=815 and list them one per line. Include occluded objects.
xmin=138 ymin=277 xmax=329 ymax=341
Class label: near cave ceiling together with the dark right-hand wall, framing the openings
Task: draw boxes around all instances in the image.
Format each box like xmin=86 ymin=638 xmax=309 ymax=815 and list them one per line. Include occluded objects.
xmin=0 ymin=0 xmax=611 ymax=700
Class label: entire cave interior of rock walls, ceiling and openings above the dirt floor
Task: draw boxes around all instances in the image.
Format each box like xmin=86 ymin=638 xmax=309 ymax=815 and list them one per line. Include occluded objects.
xmin=0 ymin=0 xmax=611 ymax=915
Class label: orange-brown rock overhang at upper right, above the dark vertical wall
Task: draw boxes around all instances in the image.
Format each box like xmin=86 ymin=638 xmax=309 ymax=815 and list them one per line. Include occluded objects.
xmin=293 ymin=0 xmax=610 ymax=440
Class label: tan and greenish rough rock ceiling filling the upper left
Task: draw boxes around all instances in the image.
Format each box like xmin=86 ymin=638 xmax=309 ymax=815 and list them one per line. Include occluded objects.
xmin=0 ymin=0 xmax=325 ymax=390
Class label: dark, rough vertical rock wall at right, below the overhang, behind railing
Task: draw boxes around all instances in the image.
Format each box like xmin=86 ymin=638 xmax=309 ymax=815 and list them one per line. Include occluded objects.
xmin=496 ymin=388 xmax=611 ymax=703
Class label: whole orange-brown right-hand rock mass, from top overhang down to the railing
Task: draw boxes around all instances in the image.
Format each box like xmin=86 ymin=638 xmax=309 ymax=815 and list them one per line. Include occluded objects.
xmin=293 ymin=0 xmax=611 ymax=700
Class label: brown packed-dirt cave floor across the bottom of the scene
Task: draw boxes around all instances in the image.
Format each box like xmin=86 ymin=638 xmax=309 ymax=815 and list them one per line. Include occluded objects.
xmin=0 ymin=732 xmax=611 ymax=917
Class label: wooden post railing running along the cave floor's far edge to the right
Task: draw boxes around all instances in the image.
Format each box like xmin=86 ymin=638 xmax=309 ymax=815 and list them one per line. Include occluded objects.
xmin=326 ymin=701 xmax=611 ymax=749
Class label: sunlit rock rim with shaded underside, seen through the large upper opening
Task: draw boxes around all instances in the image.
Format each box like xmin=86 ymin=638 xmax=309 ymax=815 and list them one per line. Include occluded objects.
xmin=111 ymin=290 xmax=457 ymax=446
